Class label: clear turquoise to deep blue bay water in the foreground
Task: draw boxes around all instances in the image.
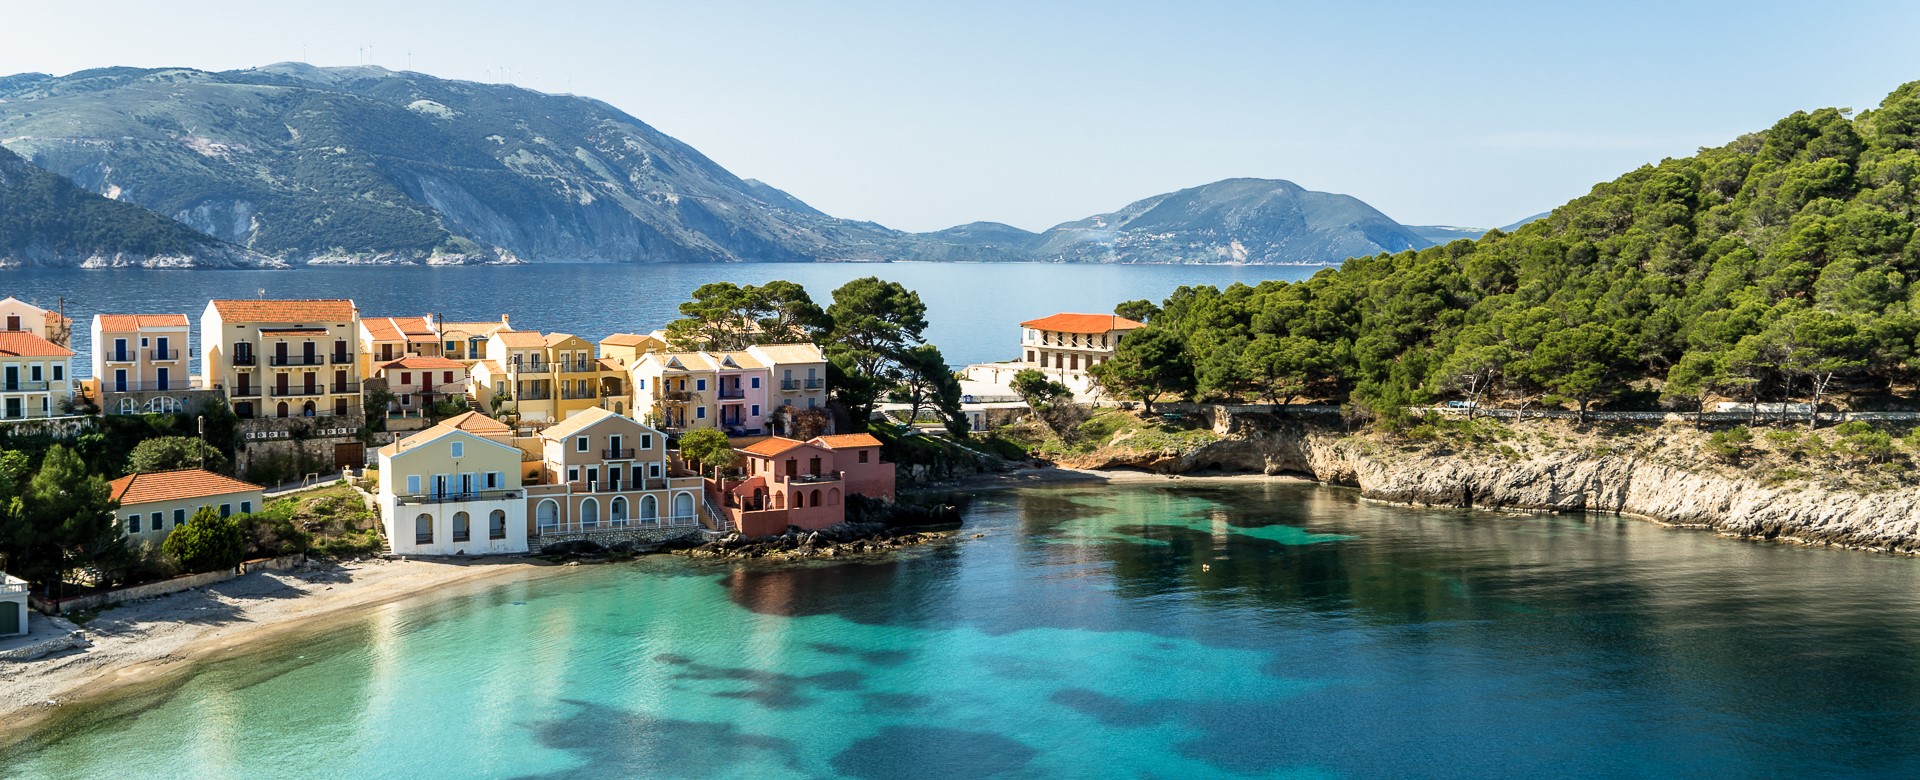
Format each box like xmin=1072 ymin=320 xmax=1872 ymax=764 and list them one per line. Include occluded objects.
xmin=0 ymin=482 xmax=1920 ymax=778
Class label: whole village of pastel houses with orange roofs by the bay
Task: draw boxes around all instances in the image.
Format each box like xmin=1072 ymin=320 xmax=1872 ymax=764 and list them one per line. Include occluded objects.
xmin=0 ymin=298 xmax=1140 ymax=636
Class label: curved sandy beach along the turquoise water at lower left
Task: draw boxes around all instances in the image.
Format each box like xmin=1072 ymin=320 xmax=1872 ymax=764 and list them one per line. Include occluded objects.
xmin=0 ymin=559 xmax=545 ymax=734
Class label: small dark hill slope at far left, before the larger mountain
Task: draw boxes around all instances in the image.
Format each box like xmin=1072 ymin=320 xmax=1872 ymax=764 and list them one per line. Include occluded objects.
xmin=0 ymin=148 xmax=273 ymax=267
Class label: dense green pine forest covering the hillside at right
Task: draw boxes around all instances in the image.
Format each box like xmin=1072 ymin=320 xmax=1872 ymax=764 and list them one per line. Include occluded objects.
xmin=1100 ymin=83 xmax=1920 ymax=417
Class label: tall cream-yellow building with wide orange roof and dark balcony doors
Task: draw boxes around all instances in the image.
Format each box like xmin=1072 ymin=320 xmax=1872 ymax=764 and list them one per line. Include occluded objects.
xmin=200 ymin=298 xmax=361 ymax=419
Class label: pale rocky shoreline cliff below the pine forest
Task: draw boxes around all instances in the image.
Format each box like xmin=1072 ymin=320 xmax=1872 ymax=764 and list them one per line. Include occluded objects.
xmin=1075 ymin=409 xmax=1920 ymax=553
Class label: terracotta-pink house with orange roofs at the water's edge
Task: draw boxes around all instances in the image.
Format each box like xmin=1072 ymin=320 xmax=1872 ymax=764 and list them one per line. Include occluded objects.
xmin=707 ymin=434 xmax=895 ymax=536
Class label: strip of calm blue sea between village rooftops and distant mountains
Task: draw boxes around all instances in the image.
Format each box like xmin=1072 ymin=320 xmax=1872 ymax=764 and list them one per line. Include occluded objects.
xmin=0 ymin=263 xmax=1319 ymax=377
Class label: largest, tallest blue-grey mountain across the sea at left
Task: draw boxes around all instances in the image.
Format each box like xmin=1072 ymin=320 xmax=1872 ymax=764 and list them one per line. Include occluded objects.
xmin=0 ymin=63 xmax=895 ymax=263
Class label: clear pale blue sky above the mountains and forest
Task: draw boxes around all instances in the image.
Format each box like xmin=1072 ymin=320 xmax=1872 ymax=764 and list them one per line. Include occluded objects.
xmin=0 ymin=0 xmax=1920 ymax=231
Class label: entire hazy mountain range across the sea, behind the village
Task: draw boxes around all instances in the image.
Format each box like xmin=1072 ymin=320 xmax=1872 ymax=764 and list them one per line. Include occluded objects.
xmin=0 ymin=63 xmax=1536 ymax=267
